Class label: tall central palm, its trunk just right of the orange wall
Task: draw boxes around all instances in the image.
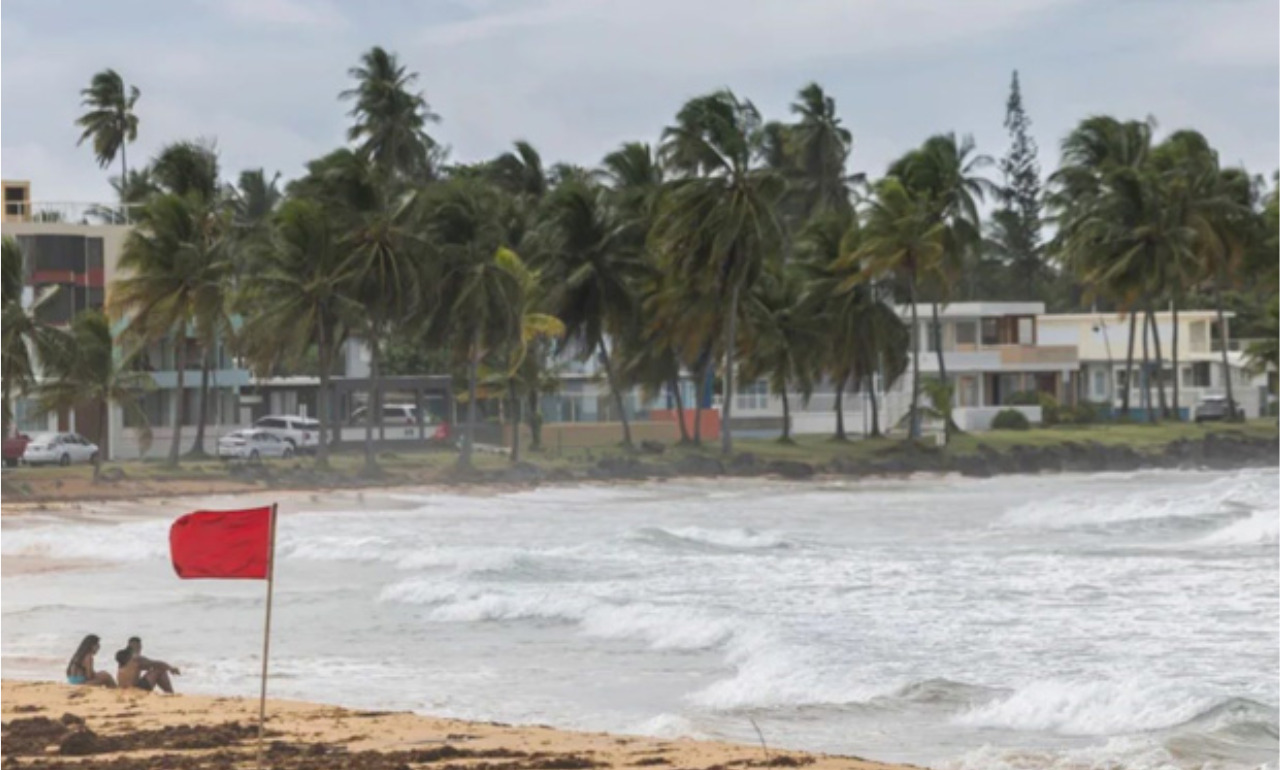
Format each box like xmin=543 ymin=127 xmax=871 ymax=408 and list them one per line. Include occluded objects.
xmin=655 ymin=91 xmax=786 ymax=455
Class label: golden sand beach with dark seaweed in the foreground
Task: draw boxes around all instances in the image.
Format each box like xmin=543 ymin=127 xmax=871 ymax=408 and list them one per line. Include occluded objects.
xmin=0 ymin=680 xmax=908 ymax=770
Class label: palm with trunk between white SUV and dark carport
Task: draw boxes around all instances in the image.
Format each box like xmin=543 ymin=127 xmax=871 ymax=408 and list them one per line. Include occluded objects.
xmin=237 ymin=198 xmax=362 ymax=468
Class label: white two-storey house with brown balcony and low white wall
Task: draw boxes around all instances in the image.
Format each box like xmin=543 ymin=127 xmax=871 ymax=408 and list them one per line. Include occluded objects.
xmin=733 ymin=302 xmax=1079 ymax=435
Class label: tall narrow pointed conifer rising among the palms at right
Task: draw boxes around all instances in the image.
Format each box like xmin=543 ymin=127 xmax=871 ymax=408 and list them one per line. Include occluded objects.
xmin=996 ymin=70 xmax=1044 ymax=299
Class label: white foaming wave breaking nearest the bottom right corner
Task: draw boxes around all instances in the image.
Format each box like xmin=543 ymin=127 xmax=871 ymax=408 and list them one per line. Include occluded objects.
xmin=952 ymin=679 xmax=1217 ymax=735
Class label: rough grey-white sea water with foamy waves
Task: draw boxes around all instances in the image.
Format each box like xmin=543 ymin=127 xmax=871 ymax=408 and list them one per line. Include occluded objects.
xmin=0 ymin=469 xmax=1280 ymax=770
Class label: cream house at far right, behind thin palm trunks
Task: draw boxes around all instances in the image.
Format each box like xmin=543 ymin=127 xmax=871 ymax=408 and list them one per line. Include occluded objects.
xmin=1039 ymin=310 xmax=1267 ymax=420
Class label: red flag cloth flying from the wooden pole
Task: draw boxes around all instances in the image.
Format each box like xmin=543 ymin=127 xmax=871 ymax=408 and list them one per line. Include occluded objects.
xmin=169 ymin=507 xmax=271 ymax=581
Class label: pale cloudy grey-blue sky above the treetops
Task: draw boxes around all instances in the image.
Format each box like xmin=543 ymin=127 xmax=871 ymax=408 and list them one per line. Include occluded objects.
xmin=0 ymin=0 xmax=1280 ymax=202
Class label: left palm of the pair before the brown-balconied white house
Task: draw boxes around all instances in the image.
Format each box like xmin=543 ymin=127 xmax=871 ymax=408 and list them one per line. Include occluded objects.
xmin=837 ymin=177 xmax=946 ymax=440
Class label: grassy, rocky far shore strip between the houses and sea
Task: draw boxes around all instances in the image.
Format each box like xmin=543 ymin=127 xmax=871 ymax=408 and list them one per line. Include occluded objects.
xmin=0 ymin=423 xmax=1280 ymax=506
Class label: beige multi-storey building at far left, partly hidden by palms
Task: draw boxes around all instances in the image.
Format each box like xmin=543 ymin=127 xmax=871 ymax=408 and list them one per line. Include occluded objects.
xmin=0 ymin=180 xmax=248 ymax=459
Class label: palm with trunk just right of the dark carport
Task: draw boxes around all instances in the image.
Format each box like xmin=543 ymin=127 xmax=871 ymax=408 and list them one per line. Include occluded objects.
xmin=422 ymin=177 xmax=524 ymax=468
